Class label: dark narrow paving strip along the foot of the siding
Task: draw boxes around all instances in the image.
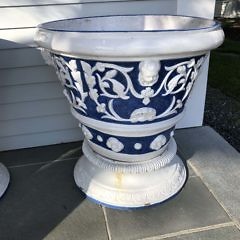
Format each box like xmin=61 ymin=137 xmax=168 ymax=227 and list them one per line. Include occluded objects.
xmin=0 ymin=142 xmax=82 ymax=167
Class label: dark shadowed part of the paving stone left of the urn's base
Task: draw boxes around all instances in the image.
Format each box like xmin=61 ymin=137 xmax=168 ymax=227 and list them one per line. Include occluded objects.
xmin=0 ymin=151 xmax=85 ymax=240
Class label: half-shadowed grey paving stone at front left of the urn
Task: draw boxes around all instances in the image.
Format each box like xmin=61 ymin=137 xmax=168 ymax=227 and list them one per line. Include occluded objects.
xmin=0 ymin=160 xmax=107 ymax=240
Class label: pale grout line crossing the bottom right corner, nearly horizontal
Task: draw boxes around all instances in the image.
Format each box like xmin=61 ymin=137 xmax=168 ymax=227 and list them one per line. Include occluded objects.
xmin=139 ymin=222 xmax=235 ymax=240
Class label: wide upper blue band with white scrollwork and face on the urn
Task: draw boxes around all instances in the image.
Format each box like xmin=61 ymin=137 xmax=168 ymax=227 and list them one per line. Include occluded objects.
xmin=51 ymin=53 xmax=205 ymax=125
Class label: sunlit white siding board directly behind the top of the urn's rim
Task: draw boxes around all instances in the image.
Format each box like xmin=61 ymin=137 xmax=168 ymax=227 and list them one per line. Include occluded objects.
xmin=0 ymin=0 xmax=173 ymax=29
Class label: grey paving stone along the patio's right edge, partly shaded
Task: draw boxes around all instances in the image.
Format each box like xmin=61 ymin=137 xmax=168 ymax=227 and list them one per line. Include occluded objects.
xmin=175 ymin=127 xmax=240 ymax=221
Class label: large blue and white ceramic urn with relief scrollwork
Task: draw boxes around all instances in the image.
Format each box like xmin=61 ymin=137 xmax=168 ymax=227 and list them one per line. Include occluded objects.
xmin=35 ymin=15 xmax=224 ymax=208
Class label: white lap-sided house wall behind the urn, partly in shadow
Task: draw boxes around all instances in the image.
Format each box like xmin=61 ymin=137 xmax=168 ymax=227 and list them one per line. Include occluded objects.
xmin=0 ymin=0 xmax=177 ymax=150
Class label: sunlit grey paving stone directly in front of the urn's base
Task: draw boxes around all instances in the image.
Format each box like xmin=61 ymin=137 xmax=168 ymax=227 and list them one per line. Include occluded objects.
xmin=106 ymin=177 xmax=230 ymax=240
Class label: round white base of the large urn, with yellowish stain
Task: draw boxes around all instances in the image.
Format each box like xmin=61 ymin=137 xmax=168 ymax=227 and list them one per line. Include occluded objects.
xmin=74 ymin=139 xmax=187 ymax=209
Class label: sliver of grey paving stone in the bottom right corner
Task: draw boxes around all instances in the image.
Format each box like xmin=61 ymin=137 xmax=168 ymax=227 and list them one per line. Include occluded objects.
xmin=165 ymin=226 xmax=240 ymax=240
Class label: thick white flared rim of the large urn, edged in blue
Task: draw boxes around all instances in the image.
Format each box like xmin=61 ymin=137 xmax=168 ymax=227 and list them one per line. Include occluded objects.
xmin=34 ymin=15 xmax=224 ymax=58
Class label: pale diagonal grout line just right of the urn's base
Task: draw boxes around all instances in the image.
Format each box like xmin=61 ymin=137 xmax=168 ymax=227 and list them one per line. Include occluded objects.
xmin=189 ymin=162 xmax=240 ymax=230
